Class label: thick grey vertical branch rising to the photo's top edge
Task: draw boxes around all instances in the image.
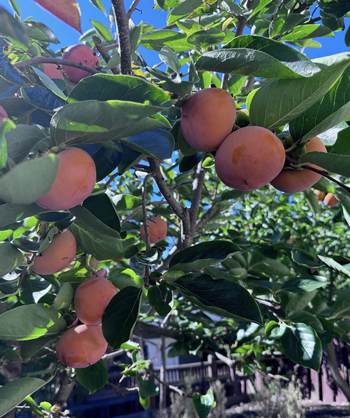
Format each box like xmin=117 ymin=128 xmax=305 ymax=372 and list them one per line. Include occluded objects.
xmin=112 ymin=0 xmax=132 ymax=75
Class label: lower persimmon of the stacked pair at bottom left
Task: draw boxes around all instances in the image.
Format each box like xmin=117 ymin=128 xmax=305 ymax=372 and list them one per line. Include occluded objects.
xmin=56 ymin=324 xmax=108 ymax=368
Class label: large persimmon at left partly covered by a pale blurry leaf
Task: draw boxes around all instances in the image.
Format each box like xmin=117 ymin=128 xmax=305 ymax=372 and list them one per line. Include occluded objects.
xmin=35 ymin=148 xmax=96 ymax=210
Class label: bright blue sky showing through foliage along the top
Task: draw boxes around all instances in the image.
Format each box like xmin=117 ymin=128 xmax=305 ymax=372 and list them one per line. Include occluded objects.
xmin=0 ymin=0 xmax=349 ymax=65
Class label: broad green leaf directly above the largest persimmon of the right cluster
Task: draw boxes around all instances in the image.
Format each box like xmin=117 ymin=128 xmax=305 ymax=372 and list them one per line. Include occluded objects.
xmin=249 ymin=53 xmax=350 ymax=129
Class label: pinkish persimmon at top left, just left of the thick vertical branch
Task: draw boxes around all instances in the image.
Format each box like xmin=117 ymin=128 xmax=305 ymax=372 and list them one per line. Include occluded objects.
xmin=63 ymin=44 xmax=101 ymax=83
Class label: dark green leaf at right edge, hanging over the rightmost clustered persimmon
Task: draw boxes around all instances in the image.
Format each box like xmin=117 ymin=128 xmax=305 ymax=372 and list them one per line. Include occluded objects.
xmin=289 ymin=68 xmax=350 ymax=142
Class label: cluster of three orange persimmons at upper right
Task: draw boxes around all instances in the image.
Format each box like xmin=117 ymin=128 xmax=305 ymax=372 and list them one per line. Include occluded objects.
xmin=181 ymin=88 xmax=327 ymax=193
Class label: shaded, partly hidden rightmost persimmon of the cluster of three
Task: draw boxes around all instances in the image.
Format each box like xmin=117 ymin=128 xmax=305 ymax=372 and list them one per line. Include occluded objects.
xmin=271 ymin=136 xmax=327 ymax=193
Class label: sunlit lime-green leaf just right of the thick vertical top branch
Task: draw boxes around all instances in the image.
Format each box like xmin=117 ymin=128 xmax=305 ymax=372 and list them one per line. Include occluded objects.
xmin=141 ymin=29 xmax=193 ymax=52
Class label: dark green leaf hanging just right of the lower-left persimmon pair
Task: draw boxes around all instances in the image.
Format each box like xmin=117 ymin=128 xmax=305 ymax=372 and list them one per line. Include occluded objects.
xmin=102 ymin=286 xmax=142 ymax=349
